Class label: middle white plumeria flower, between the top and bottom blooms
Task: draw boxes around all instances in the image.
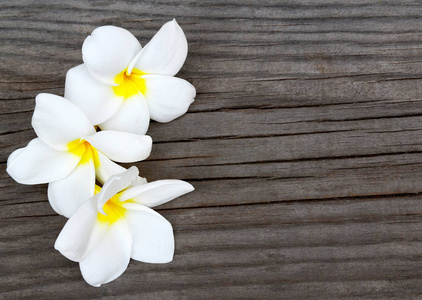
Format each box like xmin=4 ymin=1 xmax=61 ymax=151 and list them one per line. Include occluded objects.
xmin=6 ymin=94 xmax=152 ymax=217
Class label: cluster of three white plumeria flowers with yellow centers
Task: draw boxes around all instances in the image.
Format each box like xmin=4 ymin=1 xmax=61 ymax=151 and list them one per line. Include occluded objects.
xmin=7 ymin=20 xmax=196 ymax=286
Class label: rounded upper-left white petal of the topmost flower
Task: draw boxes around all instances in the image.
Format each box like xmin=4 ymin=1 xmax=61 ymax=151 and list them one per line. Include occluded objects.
xmin=82 ymin=26 xmax=142 ymax=85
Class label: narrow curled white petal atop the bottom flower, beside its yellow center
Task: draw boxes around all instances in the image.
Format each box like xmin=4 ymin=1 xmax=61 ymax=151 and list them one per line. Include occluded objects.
xmin=97 ymin=166 xmax=139 ymax=215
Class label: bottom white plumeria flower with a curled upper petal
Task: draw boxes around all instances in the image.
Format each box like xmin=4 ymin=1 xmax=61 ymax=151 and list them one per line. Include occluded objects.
xmin=54 ymin=167 xmax=194 ymax=287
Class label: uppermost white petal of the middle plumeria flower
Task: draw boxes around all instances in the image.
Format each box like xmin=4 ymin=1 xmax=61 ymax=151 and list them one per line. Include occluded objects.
xmin=32 ymin=94 xmax=95 ymax=150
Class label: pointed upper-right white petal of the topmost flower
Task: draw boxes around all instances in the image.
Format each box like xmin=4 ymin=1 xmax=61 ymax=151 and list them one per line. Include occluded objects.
xmin=134 ymin=20 xmax=188 ymax=76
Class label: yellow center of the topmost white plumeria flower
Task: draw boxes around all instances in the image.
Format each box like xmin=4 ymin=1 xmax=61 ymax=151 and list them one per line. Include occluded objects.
xmin=113 ymin=69 xmax=146 ymax=98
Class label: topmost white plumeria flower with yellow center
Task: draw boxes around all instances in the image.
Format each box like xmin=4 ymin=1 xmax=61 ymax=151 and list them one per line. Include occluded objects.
xmin=65 ymin=20 xmax=196 ymax=134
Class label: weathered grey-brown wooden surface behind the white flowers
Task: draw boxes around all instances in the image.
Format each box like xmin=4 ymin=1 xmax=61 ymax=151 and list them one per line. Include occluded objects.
xmin=0 ymin=0 xmax=422 ymax=299
